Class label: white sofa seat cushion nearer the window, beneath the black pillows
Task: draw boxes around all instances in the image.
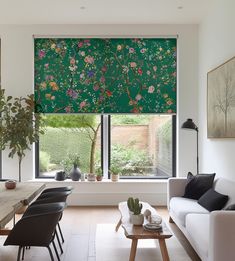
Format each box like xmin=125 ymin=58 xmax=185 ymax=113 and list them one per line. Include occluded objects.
xmin=170 ymin=197 xmax=209 ymax=226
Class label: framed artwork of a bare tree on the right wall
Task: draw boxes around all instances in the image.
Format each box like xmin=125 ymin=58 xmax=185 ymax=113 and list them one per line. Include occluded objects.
xmin=207 ymin=57 xmax=235 ymax=138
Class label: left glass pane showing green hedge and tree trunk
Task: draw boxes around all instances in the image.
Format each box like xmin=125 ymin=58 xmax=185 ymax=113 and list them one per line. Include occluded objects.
xmin=39 ymin=114 xmax=101 ymax=177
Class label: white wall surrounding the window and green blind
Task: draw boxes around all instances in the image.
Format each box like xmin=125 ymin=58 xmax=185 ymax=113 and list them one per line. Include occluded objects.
xmin=0 ymin=25 xmax=198 ymax=202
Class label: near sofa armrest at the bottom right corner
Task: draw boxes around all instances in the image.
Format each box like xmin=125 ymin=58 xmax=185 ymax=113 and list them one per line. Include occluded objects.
xmin=208 ymin=210 xmax=235 ymax=261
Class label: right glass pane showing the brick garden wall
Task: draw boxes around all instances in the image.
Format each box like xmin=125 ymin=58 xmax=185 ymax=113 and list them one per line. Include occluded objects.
xmin=110 ymin=115 xmax=172 ymax=177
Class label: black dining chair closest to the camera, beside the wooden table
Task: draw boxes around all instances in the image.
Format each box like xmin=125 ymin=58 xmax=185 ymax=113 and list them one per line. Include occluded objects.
xmin=4 ymin=202 xmax=66 ymax=261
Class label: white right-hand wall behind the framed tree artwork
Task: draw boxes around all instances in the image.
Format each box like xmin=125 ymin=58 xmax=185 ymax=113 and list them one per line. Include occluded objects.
xmin=199 ymin=0 xmax=235 ymax=180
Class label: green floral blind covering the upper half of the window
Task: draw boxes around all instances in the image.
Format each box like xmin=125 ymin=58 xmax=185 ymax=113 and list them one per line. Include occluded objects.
xmin=34 ymin=38 xmax=177 ymax=113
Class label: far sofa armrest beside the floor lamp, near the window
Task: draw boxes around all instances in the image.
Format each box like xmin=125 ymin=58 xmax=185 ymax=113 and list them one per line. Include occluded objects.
xmin=167 ymin=178 xmax=187 ymax=209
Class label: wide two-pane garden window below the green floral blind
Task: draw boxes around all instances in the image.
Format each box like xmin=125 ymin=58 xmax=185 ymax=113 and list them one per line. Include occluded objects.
xmin=36 ymin=114 xmax=176 ymax=178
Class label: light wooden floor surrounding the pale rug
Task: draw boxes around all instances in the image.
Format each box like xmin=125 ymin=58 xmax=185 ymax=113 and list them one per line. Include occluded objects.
xmin=0 ymin=207 xmax=200 ymax=261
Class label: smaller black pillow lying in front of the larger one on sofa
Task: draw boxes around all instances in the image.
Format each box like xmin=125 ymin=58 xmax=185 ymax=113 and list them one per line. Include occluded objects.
xmin=198 ymin=189 xmax=228 ymax=211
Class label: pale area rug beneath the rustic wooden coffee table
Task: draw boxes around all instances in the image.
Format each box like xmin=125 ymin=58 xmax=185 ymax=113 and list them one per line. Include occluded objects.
xmin=96 ymin=224 xmax=191 ymax=261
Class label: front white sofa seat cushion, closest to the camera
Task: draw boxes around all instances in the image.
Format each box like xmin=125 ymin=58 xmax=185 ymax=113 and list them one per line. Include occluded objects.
xmin=186 ymin=214 xmax=210 ymax=257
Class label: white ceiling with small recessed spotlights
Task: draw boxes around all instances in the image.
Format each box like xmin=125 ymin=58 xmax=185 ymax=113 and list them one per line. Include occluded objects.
xmin=0 ymin=0 xmax=213 ymax=24
